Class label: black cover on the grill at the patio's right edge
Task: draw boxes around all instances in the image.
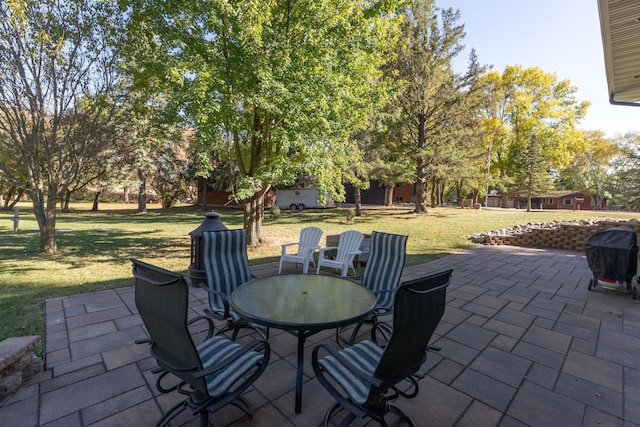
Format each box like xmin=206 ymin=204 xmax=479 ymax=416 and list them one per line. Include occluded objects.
xmin=584 ymin=227 xmax=638 ymax=282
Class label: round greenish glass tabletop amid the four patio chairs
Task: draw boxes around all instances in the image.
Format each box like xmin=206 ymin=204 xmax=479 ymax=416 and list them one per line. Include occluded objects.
xmin=231 ymin=274 xmax=376 ymax=330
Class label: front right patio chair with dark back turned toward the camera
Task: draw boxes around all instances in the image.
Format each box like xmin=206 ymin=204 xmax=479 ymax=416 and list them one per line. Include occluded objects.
xmin=311 ymin=270 xmax=452 ymax=427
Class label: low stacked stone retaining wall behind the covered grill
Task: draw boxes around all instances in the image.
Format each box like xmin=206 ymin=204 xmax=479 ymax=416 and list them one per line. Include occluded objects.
xmin=484 ymin=221 xmax=640 ymax=252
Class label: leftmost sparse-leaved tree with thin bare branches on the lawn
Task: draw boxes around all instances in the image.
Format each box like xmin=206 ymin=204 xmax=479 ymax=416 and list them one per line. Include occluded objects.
xmin=0 ymin=0 xmax=122 ymax=254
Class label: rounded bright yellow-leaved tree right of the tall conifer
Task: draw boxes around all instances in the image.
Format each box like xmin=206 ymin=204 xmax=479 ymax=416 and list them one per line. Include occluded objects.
xmin=481 ymin=65 xmax=589 ymax=209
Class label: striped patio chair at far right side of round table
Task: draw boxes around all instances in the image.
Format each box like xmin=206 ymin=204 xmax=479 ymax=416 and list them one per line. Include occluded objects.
xmin=336 ymin=231 xmax=407 ymax=345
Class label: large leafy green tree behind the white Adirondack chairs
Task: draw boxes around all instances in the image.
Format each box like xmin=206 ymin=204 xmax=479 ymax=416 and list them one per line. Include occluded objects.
xmin=125 ymin=0 xmax=398 ymax=245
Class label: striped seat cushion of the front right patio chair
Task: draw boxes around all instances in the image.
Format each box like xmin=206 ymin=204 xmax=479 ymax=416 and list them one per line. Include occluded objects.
xmin=318 ymin=340 xmax=383 ymax=404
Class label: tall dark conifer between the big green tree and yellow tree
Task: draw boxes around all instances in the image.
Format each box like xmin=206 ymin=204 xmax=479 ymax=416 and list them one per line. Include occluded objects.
xmin=391 ymin=0 xmax=483 ymax=213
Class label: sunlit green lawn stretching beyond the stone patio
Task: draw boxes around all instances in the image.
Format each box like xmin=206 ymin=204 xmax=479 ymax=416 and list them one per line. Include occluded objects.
xmin=0 ymin=203 xmax=638 ymax=352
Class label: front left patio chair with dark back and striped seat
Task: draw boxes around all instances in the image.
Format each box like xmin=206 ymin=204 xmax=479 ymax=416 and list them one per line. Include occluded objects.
xmin=132 ymin=260 xmax=270 ymax=427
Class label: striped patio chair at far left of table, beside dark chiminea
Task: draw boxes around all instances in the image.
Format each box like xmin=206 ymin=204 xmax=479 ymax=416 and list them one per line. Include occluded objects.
xmin=200 ymin=228 xmax=269 ymax=341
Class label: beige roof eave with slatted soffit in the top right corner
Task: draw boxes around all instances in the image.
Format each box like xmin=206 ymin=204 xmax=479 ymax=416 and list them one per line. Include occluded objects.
xmin=598 ymin=0 xmax=640 ymax=106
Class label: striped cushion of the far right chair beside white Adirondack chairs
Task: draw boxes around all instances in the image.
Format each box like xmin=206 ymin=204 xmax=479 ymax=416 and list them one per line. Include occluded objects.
xmin=362 ymin=231 xmax=407 ymax=309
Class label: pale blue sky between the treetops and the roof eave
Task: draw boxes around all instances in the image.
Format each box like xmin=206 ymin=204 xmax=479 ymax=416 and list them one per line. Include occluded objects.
xmin=436 ymin=0 xmax=640 ymax=137
